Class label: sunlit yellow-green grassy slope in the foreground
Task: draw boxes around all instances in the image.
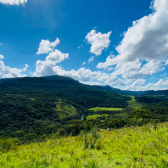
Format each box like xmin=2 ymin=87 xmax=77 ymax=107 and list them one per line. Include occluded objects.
xmin=0 ymin=123 xmax=168 ymax=168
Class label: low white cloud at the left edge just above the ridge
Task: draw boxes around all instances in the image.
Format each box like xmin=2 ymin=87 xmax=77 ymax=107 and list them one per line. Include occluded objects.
xmin=0 ymin=55 xmax=29 ymax=78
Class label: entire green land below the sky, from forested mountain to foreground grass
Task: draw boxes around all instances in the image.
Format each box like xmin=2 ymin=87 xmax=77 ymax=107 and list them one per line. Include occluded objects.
xmin=0 ymin=76 xmax=168 ymax=168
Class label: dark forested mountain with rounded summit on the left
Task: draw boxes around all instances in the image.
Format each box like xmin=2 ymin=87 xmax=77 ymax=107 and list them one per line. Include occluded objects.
xmin=0 ymin=76 xmax=130 ymax=136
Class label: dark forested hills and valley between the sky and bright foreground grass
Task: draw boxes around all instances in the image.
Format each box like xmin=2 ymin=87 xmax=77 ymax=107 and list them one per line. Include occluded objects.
xmin=0 ymin=76 xmax=168 ymax=141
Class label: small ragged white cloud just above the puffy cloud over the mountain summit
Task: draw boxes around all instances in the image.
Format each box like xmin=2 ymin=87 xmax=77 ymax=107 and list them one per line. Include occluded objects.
xmin=37 ymin=38 xmax=60 ymax=54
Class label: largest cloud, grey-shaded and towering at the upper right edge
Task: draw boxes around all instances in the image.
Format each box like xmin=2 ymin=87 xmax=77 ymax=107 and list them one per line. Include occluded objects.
xmin=97 ymin=0 xmax=168 ymax=79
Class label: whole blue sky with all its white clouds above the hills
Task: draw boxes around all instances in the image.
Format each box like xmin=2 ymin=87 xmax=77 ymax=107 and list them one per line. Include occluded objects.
xmin=0 ymin=0 xmax=168 ymax=91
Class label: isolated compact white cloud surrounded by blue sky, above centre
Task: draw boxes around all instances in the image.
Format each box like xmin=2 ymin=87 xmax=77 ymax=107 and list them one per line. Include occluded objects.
xmin=85 ymin=30 xmax=112 ymax=56
